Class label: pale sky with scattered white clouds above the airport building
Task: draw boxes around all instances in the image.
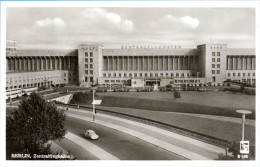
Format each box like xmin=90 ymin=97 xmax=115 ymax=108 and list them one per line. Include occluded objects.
xmin=6 ymin=7 xmax=255 ymax=49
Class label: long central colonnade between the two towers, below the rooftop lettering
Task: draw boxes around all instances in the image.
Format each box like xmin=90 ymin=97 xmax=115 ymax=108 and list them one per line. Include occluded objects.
xmin=103 ymin=55 xmax=199 ymax=71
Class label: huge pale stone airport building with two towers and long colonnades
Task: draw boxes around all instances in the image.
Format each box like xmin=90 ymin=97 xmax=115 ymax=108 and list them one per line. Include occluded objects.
xmin=6 ymin=42 xmax=255 ymax=89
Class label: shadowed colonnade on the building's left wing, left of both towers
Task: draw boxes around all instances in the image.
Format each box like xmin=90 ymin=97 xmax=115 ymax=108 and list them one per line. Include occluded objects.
xmin=6 ymin=56 xmax=78 ymax=71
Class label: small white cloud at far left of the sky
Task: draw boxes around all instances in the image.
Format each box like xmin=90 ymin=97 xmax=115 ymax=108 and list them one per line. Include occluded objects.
xmin=35 ymin=18 xmax=65 ymax=28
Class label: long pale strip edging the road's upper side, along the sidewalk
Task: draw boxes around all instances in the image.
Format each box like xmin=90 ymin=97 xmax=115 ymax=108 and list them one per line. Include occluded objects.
xmin=68 ymin=113 xmax=210 ymax=160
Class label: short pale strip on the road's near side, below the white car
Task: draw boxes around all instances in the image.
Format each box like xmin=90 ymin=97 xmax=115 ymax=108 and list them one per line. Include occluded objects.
xmin=65 ymin=132 xmax=119 ymax=160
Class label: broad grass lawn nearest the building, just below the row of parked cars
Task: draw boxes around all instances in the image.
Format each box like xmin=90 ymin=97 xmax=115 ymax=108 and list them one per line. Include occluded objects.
xmin=97 ymin=92 xmax=255 ymax=119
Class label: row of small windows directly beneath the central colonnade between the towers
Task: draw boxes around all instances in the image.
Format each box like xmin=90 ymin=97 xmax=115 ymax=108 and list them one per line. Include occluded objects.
xmin=103 ymin=73 xmax=202 ymax=77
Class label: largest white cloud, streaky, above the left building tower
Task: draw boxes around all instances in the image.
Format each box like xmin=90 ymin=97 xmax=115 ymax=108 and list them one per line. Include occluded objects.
xmin=81 ymin=8 xmax=134 ymax=33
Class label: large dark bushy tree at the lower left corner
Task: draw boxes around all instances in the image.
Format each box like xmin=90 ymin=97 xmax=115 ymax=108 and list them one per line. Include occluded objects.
xmin=6 ymin=92 xmax=66 ymax=159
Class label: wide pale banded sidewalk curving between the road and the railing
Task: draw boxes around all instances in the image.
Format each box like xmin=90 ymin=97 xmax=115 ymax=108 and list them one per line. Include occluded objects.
xmin=62 ymin=108 xmax=225 ymax=160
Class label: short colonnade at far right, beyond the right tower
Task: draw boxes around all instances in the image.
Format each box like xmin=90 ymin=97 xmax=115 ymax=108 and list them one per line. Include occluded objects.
xmin=227 ymin=56 xmax=255 ymax=70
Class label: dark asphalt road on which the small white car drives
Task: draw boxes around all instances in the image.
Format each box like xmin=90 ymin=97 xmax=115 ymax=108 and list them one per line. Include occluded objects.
xmin=65 ymin=117 xmax=184 ymax=160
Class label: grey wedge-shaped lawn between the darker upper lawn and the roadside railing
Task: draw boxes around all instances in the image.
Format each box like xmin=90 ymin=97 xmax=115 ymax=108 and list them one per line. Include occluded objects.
xmin=97 ymin=106 xmax=255 ymax=145
